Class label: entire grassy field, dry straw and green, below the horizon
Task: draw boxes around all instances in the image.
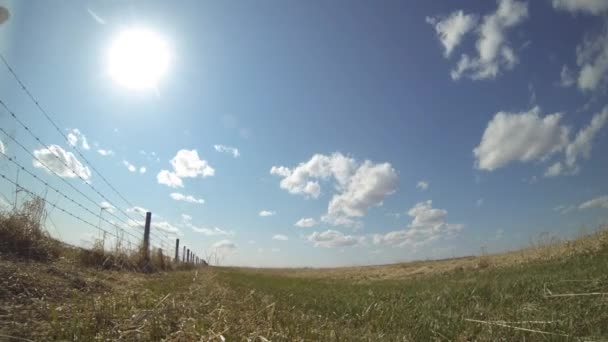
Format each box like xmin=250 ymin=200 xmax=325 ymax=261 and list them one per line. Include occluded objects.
xmin=0 ymin=227 xmax=608 ymax=341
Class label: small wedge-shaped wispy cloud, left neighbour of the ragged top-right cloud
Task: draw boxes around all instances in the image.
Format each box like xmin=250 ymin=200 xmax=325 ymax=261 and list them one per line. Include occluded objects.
xmin=426 ymin=10 xmax=477 ymax=58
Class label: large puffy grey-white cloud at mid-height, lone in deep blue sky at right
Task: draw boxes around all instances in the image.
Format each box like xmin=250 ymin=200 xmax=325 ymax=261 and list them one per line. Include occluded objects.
xmin=473 ymin=107 xmax=569 ymax=171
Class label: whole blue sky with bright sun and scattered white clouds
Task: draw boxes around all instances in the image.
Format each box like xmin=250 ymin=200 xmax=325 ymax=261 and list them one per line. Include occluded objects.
xmin=0 ymin=0 xmax=608 ymax=267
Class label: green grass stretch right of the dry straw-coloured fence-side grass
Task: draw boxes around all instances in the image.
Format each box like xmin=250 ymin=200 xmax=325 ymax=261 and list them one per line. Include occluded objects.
xmin=220 ymin=250 xmax=608 ymax=341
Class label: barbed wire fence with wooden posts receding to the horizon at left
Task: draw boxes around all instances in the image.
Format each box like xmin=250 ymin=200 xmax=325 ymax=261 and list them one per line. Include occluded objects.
xmin=0 ymin=53 xmax=206 ymax=265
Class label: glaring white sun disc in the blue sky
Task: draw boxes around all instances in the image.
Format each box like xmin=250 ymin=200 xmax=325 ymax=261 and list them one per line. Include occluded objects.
xmin=108 ymin=29 xmax=170 ymax=89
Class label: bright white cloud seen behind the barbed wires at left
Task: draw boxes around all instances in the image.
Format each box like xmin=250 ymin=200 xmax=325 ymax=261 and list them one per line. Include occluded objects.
xmin=33 ymin=145 xmax=91 ymax=181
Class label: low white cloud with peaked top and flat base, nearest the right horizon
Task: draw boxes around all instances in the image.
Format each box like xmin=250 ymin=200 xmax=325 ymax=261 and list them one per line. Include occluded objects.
xmin=373 ymin=200 xmax=464 ymax=247
